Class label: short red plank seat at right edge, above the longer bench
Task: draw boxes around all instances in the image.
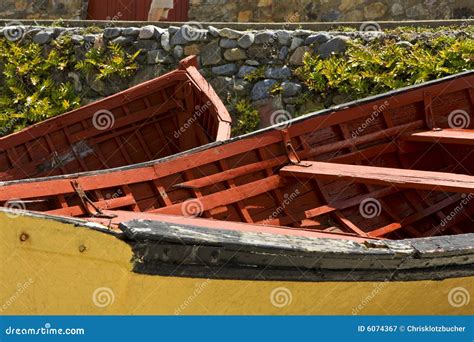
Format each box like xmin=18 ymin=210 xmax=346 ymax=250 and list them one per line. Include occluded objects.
xmin=402 ymin=128 xmax=474 ymax=145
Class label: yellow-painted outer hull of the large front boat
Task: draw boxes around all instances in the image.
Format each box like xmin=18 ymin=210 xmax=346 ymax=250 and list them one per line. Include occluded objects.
xmin=0 ymin=212 xmax=474 ymax=315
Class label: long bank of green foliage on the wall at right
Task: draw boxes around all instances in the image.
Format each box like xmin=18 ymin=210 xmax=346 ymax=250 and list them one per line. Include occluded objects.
xmin=296 ymin=36 xmax=474 ymax=98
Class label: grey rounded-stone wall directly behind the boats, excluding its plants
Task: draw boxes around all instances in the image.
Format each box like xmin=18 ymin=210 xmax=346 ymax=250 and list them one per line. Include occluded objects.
xmin=0 ymin=25 xmax=466 ymax=126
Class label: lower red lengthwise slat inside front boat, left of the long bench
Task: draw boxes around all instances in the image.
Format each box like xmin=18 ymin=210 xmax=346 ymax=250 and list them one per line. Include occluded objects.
xmin=154 ymin=175 xmax=284 ymax=215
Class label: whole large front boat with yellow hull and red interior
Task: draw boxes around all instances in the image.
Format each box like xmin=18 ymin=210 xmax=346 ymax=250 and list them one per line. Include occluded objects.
xmin=0 ymin=71 xmax=474 ymax=314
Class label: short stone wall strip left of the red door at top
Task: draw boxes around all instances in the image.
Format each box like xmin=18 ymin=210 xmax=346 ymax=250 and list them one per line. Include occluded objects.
xmin=0 ymin=0 xmax=88 ymax=19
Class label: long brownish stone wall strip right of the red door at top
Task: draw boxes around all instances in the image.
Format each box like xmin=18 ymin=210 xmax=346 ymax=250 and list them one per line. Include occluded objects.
xmin=189 ymin=0 xmax=474 ymax=22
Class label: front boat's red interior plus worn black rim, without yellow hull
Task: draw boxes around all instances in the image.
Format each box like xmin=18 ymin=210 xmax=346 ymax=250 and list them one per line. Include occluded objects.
xmin=0 ymin=71 xmax=474 ymax=281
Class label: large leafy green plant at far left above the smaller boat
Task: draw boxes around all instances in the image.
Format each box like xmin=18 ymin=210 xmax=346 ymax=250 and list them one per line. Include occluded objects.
xmin=0 ymin=40 xmax=80 ymax=135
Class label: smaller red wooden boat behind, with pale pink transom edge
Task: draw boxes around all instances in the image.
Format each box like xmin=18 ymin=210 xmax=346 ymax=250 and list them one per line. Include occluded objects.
xmin=0 ymin=56 xmax=231 ymax=180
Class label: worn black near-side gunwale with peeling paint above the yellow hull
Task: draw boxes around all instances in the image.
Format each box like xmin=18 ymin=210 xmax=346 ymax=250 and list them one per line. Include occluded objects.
xmin=0 ymin=208 xmax=474 ymax=282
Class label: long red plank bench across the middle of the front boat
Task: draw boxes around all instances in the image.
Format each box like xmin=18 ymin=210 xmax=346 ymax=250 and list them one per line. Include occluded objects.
xmin=280 ymin=161 xmax=474 ymax=193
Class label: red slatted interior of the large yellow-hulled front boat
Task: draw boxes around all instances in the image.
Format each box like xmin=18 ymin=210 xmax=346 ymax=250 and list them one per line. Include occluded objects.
xmin=0 ymin=72 xmax=474 ymax=240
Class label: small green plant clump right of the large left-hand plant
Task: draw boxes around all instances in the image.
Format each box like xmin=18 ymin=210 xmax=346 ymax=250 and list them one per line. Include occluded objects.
xmin=76 ymin=44 xmax=140 ymax=80
